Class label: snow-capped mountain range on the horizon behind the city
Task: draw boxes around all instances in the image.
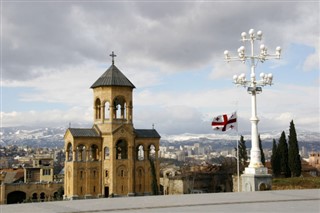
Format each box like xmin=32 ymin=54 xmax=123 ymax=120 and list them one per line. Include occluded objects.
xmin=0 ymin=127 xmax=320 ymax=147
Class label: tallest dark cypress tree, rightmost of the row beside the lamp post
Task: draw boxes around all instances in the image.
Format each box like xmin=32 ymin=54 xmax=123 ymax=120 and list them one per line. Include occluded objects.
xmin=288 ymin=120 xmax=301 ymax=177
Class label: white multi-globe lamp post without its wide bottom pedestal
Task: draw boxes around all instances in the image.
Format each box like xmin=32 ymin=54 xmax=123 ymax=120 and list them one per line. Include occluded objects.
xmin=224 ymin=29 xmax=281 ymax=191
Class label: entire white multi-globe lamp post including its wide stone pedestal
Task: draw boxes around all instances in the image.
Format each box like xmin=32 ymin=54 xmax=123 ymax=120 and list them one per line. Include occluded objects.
xmin=224 ymin=29 xmax=281 ymax=191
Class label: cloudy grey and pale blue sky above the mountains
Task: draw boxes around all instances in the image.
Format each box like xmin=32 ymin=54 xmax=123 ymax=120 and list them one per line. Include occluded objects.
xmin=1 ymin=0 xmax=320 ymax=134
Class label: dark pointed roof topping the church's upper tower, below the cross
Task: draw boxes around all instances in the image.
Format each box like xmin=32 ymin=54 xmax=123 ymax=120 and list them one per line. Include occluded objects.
xmin=91 ymin=64 xmax=136 ymax=89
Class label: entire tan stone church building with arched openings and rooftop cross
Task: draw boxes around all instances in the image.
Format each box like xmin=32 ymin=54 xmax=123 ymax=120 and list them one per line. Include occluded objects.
xmin=64 ymin=52 xmax=160 ymax=199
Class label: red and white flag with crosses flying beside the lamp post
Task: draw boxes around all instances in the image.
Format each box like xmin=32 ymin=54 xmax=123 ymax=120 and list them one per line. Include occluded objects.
xmin=211 ymin=112 xmax=238 ymax=132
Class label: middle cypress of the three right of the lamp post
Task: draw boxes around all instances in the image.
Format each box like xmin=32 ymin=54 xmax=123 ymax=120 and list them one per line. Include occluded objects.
xmin=277 ymin=131 xmax=291 ymax=178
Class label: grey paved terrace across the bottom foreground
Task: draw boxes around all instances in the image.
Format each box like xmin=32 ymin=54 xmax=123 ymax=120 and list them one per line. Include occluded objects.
xmin=0 ymin=189 xmax=320 ymax=213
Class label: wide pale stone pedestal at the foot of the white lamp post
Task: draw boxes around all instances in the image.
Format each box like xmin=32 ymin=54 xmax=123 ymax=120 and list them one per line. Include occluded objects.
xmin=241 ymin=167 xmax=272 ymax=192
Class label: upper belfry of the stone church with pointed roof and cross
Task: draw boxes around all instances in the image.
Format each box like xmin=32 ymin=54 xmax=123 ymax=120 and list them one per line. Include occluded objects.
xmin=91 ymin=52 xmax=135 ymax=133
